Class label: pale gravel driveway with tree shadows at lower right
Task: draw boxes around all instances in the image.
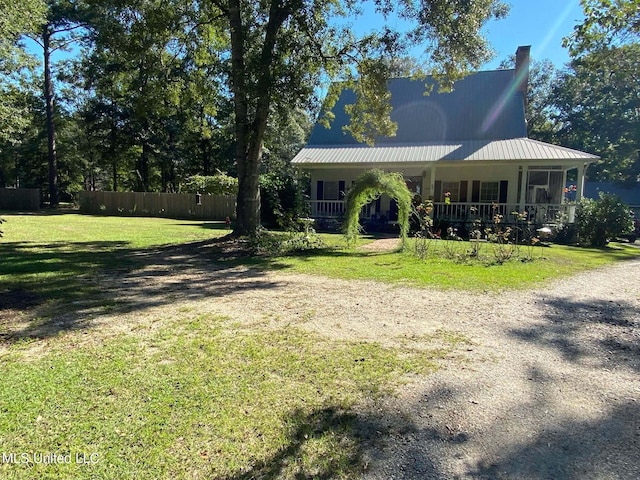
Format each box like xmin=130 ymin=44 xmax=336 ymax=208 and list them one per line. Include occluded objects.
xmin=356 ymin=261 xmax=640 ymax=480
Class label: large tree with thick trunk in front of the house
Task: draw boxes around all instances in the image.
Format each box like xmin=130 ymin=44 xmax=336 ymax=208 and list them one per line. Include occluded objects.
xmin=208 ymin=0 xmax=506 ymax=235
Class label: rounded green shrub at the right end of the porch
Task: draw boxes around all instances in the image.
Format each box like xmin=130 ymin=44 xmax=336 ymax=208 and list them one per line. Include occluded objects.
xmin=576 ymin=192 xmax=633 ymax=247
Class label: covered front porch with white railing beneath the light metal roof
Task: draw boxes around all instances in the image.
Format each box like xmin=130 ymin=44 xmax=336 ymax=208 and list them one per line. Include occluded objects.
xmin=308 ymin=162 xmax=586 ymax=228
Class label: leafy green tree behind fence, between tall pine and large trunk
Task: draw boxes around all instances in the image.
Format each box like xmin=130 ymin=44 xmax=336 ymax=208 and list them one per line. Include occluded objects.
xmin=80 ymin=0 xmax=230 ymax=191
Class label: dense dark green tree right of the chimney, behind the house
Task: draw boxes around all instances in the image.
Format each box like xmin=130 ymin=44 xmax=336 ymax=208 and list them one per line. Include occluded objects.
xmin=553 ymin=44 xmax=640 ymax=182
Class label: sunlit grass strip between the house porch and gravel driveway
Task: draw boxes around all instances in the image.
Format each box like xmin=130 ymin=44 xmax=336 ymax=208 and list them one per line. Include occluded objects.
xmin=251 ymin=234 xmax=640 ymax=291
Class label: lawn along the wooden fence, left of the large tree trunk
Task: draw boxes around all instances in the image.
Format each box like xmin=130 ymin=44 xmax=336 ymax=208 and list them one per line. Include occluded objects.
xmin=0 ymin=214 xmax=227 ymax=301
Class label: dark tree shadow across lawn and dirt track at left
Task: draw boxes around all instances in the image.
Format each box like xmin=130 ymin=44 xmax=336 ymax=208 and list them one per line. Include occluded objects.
xmin=0 ymin=239 xmax=285 ymax=343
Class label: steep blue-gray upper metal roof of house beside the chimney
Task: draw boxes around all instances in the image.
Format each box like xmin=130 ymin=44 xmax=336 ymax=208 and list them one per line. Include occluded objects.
xmin=309 ymin=70 xmax=527 ymax=145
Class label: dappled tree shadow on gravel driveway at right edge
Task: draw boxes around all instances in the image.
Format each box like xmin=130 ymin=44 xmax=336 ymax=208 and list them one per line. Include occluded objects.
xmin=510 ymin=297 xmax=640 ymax=372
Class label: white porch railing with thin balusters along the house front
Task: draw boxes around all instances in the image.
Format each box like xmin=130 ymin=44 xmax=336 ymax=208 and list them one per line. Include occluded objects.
xmin=309 ymin=200 xmax=575 ymax=223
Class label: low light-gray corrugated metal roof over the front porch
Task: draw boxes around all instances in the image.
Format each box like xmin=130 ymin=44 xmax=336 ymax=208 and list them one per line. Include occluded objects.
xmin=292 ymin=138 xmax=599 ymax=167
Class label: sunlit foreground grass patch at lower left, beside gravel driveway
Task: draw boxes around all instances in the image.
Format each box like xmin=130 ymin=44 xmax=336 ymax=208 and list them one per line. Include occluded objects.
xmin=0 ymin=315 xmax=450 ymax=480
